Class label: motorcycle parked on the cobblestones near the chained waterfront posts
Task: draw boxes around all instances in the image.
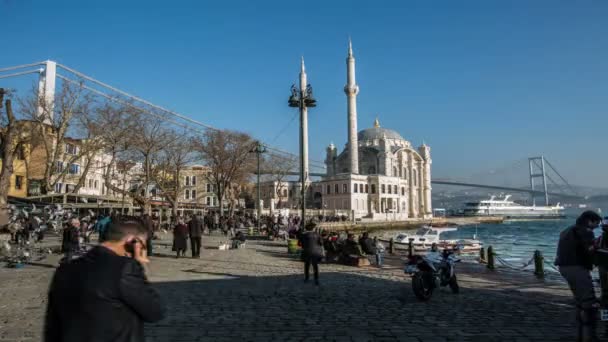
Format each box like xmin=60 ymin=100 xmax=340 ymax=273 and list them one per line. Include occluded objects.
xmin=404 ymin=247 xmax=460 ymax=301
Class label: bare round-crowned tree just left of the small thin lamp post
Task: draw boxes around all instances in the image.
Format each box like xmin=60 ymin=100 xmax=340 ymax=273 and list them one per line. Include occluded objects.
xmin=195 ymin=130 xmax=255 ymax=214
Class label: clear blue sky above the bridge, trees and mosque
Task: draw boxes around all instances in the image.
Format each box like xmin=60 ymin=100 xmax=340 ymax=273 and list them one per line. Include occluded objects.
xmin=0 ymin=0 xmax=608 ymax=187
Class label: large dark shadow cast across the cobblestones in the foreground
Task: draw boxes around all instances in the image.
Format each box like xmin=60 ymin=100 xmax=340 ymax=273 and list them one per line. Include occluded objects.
xmin=146 ymin=266 xmax=575 ymax=341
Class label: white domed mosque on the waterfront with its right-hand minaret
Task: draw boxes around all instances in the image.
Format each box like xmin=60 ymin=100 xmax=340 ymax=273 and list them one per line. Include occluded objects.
xmin=311 ymin=42 xmax=432 ymax=220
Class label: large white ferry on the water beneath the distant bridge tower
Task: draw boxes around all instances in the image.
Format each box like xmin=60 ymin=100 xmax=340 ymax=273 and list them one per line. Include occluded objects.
xmin=464 ymin=195 xmax=564 ymax=219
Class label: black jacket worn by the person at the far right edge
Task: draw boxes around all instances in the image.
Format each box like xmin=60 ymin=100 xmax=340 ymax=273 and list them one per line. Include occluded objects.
xmin=555 ymin=225 xmax=595 ymax=270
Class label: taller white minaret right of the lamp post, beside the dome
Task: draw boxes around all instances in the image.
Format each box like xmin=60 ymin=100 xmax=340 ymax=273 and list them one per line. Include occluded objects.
xmin=344 ymin=39 xmax=359 ymax=174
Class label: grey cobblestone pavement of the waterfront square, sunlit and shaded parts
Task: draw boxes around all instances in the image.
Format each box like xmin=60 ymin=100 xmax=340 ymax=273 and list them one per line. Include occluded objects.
xmin=0 ymin=237 xmax=588 ymax=342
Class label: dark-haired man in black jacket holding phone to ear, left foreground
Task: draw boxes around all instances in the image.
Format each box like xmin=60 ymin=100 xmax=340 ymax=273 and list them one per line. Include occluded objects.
xmin=44 ymin=221 xmax=165 ymax=342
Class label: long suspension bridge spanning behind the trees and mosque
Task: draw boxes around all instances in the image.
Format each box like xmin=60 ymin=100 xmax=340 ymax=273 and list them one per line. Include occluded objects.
xmin=0 ymin=61 xmax=608 ymax=204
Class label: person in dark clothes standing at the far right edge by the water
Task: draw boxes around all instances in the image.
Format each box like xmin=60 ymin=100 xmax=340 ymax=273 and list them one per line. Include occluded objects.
xmin=555 ymin=211 xmax=602 ymax=342
